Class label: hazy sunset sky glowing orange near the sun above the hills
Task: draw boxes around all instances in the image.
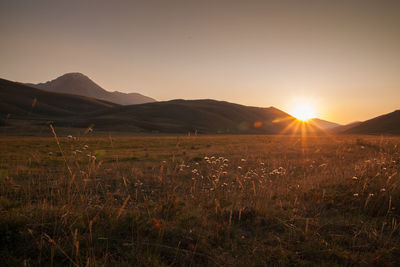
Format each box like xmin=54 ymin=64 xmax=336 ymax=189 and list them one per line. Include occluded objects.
xmin=0 ymin=0 xmax=400 ymax=124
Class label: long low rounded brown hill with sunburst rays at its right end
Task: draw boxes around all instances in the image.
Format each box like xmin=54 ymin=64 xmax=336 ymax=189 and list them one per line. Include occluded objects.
xmin=72 ymin=99 xmax=320 ymax=134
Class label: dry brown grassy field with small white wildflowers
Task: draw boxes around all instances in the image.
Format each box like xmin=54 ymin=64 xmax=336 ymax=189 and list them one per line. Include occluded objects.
xmin=0 ymin=135 xmax=400 ymax=266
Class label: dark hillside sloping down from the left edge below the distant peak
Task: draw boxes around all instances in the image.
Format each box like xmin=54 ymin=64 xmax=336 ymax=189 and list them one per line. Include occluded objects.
xmin=0 ymin=79 xmax=118 ymax=119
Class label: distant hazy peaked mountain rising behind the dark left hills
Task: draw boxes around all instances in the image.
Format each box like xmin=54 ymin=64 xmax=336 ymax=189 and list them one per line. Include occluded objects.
xmin=27 ymin=73 xmax=156 ymax=105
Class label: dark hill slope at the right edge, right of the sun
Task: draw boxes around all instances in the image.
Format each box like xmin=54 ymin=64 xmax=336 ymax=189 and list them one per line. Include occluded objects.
xmin=341 ymin=110 xmax=400 ymax=134
